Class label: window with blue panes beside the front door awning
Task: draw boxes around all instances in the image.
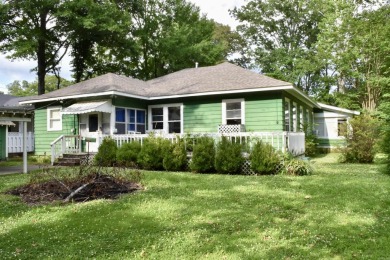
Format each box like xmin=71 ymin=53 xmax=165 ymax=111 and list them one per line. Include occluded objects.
xmin=115 ymin=107 xmax=146 ymax=134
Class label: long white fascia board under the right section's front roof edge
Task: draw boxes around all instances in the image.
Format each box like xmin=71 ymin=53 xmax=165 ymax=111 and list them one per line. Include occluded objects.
xmin=149 ymin=85 xmax=294 ymax=100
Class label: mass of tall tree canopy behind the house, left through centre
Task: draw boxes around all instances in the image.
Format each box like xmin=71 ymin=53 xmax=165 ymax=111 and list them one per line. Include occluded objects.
xmin=0 ymin=0 xmax=238 ymax=94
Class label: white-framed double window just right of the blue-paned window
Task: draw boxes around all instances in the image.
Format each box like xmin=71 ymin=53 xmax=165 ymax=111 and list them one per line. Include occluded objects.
xmin=149 ymin=104 xmax=183 ymax=134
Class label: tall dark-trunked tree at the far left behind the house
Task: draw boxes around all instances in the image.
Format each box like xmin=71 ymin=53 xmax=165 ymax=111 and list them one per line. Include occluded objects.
xmin=0 ymin=0 xmax=65 ymax=95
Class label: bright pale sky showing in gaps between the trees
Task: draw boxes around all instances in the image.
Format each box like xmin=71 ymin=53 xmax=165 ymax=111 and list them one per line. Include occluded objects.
xmin=0 ymin=0 xmax=245 ymax=93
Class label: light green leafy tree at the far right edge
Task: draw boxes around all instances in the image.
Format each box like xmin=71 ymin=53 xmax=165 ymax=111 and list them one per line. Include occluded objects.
xmin=318 ymin=1 xmax=390 ymax=113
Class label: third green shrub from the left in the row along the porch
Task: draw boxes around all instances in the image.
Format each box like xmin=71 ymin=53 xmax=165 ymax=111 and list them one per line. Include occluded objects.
xmin=137 ymin=135 xmax=170 ymax=170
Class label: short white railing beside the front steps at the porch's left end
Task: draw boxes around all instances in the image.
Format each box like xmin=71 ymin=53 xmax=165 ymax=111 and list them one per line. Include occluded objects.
xmin=50 ymin=135 xmax=81 ymax=165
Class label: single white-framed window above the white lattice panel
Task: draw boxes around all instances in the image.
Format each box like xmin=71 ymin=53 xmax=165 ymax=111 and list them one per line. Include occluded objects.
xmin=222 ymin=99 xmax=245 ymax=125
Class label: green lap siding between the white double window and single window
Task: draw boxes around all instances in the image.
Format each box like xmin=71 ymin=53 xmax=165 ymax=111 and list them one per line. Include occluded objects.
xmin=184 ymin=99 xmax=222 ymax=133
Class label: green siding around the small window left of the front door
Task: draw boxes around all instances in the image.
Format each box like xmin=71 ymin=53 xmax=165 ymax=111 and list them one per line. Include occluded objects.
xmin=34 ymin=108 xmax=78 ymax=155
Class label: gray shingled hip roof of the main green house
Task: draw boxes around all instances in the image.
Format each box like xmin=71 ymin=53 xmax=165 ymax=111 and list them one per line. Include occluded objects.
xmin=19 ymin=62 xmax=291 ymax=101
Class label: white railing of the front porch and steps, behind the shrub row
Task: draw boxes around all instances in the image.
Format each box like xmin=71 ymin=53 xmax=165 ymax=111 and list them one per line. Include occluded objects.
xmin=51 ymin=132 xmax=305 ymax=164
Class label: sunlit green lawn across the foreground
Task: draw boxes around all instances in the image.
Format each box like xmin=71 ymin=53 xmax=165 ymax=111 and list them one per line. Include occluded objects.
xmin=0 ymin=154 xmax=390 ymax=259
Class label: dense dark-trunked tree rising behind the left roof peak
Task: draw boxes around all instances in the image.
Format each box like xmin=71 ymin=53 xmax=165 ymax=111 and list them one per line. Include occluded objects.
xmin=57 ymin=0 xmax=133 ymax=82
